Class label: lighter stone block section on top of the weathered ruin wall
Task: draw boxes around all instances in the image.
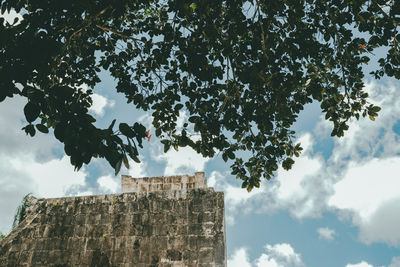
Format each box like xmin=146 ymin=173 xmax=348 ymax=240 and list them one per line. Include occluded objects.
xmin=121 ymin=172 xmax=207 ymax=193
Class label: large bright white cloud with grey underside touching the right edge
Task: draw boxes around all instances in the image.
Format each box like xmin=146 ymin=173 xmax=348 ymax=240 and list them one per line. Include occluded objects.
xmin=329 ymin=157 xmax=400 ymax=245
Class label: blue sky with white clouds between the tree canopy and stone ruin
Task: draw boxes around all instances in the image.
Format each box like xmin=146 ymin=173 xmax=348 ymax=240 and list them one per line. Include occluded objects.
xmin=0 ymin=8 xmax=400 ymax=267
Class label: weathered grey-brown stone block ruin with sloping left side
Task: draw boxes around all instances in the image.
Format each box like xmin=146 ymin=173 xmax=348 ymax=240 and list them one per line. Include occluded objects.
xmin=0 ymin=172 xmax=226 ymax=267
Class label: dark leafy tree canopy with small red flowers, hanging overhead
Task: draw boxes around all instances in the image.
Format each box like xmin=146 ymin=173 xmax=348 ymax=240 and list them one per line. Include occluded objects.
xmin=0 ymin=0 xmax=400 ymax=190
